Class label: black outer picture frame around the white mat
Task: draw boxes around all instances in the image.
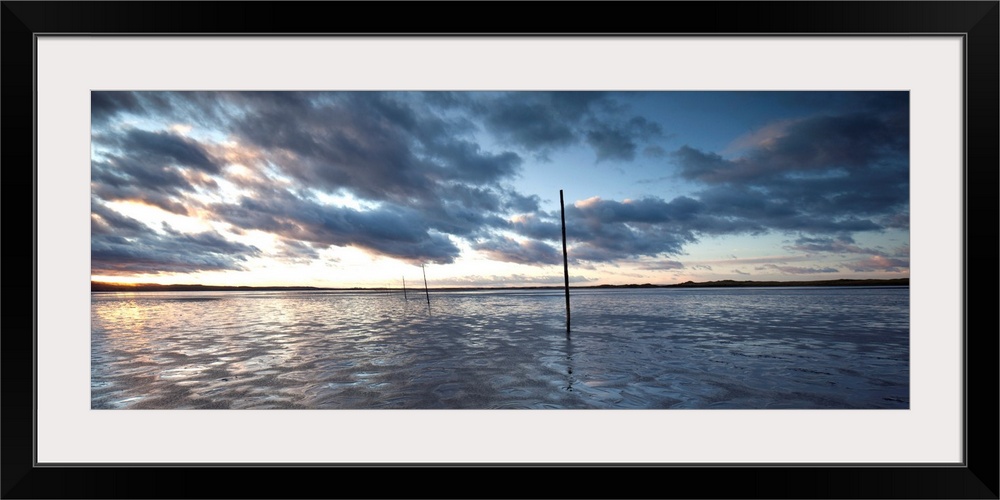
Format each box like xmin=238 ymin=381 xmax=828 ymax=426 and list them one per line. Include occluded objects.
xmin=0 ymin=1 xmax=1000 ymax=498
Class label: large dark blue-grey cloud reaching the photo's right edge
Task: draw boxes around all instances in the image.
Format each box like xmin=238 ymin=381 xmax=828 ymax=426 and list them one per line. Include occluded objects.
xmin=672 ymin=99 xmax=909 ymax=240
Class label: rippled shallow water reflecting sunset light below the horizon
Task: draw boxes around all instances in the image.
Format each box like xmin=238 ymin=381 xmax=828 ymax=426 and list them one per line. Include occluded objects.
xmin=91 ymin=287 xmax=909 ymax=409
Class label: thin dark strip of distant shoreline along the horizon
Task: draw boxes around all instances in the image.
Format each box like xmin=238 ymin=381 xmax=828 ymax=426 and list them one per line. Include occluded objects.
xmin=90 ymin=278 xmax=910 ymax=292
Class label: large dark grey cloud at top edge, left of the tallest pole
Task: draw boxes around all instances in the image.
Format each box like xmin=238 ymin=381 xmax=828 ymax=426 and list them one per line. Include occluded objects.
xmin=188 ymin=92 xmax=530 ymax=215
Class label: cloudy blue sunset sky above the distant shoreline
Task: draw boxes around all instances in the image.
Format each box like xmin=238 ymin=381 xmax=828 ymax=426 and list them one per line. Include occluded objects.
xmin=91 ymin=91 xmax=909 ymax=287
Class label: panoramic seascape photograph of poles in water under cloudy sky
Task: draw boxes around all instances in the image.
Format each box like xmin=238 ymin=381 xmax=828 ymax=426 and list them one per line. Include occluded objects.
xmin=90 ymin=90 xmax=910 ymax=410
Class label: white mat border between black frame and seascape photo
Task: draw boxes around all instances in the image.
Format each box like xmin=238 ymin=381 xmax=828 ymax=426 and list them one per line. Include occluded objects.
xmin=37 ymin=35 xmax=964 ymax=465
